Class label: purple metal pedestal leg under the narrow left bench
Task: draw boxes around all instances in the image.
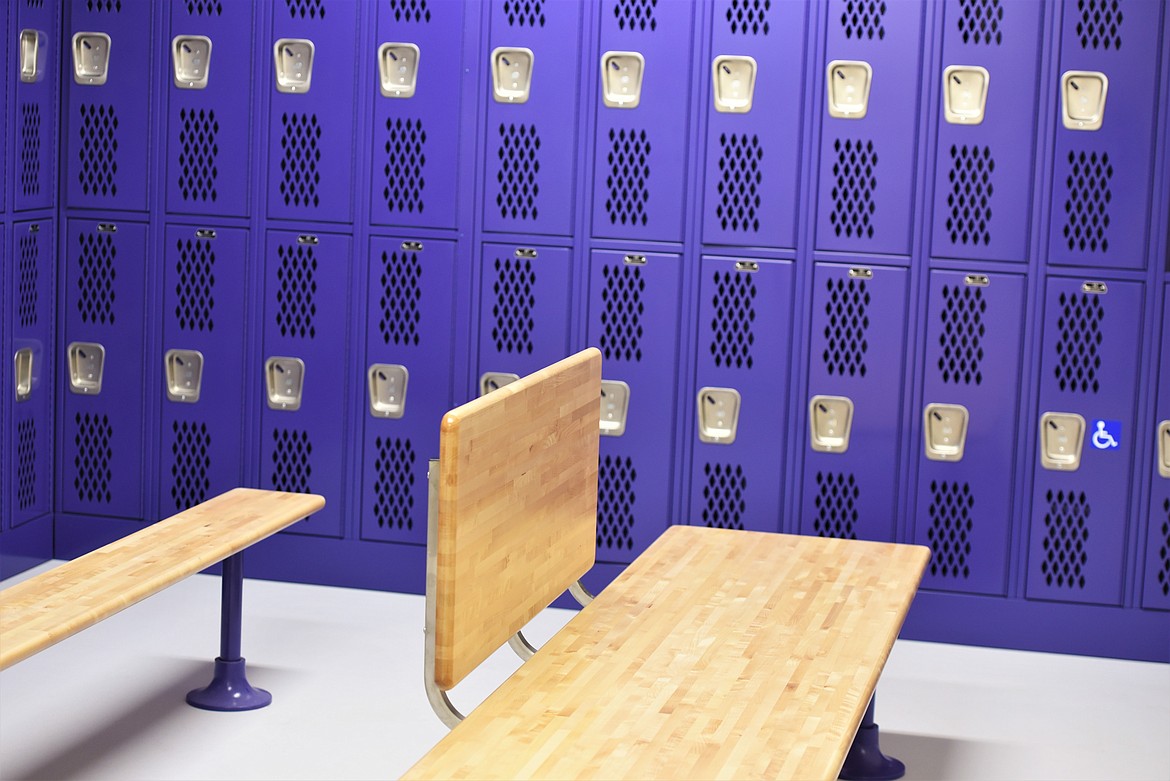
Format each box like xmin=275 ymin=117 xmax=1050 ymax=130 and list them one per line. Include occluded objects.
xmin=187 ymin=552 xmax=273 ymax=711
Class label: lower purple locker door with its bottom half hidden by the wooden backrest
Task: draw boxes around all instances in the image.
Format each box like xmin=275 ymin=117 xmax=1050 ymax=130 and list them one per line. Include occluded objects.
xmin=476 ymin=244 xmax=572 ymax=376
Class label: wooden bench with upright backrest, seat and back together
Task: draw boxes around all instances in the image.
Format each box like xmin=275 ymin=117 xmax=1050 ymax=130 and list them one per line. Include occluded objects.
xmin=404 ymin=350 xmax=929 ymax=779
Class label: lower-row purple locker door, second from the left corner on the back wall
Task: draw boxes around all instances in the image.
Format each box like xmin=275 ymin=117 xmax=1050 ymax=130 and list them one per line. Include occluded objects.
xmin=157 ymin=226 xmax=248 ymax=518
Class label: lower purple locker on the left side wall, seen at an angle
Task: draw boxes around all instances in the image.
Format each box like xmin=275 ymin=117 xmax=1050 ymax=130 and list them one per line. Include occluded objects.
xmin=5 ymin=220 xmax=56 ymax=526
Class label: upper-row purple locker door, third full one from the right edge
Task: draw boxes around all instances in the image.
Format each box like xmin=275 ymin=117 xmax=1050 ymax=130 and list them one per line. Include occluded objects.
xmin=813 ymin=0 xmax=923 ymax=255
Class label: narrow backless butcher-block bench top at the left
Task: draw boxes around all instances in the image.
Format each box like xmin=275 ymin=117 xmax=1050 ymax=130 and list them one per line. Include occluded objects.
xmin=0 ymin=488 xmax=325 ymax=670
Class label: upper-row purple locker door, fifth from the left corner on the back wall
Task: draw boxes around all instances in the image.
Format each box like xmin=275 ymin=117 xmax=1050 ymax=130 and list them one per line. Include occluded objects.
xmin=483 ymin=0 xmax=584 ymax=236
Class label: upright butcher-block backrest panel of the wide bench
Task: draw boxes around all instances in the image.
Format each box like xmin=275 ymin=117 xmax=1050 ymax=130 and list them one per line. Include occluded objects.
xmin=433 ymin=348 xmax=601 ymax=690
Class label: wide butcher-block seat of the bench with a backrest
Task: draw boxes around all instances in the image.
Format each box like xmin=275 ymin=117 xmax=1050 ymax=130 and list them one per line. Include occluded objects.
xmin=405 ymin=526 xmax=929 ymax=779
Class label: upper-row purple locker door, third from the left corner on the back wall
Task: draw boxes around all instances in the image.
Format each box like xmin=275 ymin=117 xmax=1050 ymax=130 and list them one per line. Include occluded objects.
xmin=265 ymin=0 xmax=362 ymax=225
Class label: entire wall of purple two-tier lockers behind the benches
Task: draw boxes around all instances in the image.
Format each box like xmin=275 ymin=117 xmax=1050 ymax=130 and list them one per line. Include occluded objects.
xmin=0 ymin=0 xmax=1170 ymax=661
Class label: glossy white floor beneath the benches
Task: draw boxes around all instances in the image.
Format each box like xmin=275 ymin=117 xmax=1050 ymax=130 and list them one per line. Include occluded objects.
xmin=0 ymin=567 xmax=1170 ymax=781
